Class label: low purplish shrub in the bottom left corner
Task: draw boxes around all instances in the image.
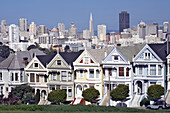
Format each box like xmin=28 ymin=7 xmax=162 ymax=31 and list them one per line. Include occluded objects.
xmin=0 ymin=92 xmax=21 ymax=105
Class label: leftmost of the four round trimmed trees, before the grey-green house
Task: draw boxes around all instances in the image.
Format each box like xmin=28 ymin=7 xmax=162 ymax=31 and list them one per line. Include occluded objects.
xmin=47 ymin=89 xmax=67 ymax=105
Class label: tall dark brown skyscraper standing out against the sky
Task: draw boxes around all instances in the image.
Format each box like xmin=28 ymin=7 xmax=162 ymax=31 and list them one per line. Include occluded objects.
xmin=119 ymin=11 xmax=130 ymax=32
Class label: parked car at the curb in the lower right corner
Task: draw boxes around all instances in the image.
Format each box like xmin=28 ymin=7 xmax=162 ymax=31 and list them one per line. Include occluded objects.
xmin=146 ymin=100 xmax=167 ymax=109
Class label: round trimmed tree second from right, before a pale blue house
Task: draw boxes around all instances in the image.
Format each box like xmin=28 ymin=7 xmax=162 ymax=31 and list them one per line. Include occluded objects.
xmin=110 ymin=84 xmax=129 ymax=101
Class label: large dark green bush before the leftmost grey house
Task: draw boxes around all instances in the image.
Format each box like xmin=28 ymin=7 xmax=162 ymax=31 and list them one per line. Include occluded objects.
xmin=12 ymin=85 xmax=32 ymax=104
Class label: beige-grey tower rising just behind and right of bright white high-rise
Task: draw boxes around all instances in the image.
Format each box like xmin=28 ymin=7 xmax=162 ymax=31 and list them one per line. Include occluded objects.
xmin=19 ymin=18 xmax=28 ymax=32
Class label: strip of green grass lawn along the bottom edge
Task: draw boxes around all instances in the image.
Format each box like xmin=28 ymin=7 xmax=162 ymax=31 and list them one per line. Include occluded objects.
xmin=0 ymin=105 xmax=170 ymax=113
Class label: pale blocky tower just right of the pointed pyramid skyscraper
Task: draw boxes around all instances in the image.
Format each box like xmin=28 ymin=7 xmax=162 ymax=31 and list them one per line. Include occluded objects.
xmin=97 ymin=25 xmax=106 ymax=41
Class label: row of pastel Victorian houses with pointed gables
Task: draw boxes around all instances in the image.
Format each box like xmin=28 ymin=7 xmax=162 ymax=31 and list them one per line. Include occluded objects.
xmin=0 ymin=43 xmax=170 ymax=107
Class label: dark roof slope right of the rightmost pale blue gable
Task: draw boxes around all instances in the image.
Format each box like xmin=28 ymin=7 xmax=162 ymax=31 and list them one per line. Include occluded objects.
xmin=148 ymin=42 xmax=170 ymax=61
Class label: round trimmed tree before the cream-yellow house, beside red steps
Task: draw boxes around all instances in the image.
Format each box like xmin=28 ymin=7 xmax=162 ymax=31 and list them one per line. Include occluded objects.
xmin=82 ymin=88 xmax=100 ymax=103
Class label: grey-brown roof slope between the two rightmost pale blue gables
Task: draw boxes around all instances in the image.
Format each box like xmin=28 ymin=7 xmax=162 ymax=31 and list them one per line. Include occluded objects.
xmin=116 ymin=44 xmax=145 ymax=62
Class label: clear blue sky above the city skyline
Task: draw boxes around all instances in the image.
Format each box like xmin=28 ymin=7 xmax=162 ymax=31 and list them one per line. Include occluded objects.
xmin=0 ymin=0 xmax=170 ymax=32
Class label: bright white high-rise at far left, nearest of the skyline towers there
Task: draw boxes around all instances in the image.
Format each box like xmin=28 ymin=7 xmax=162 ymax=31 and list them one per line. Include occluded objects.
xmin=9 ymin=24 xmax=19 ymax=43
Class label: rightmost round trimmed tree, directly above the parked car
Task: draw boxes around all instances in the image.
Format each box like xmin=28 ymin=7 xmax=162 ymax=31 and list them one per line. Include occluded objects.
xmin=147 ymin=84 xmax=165 ymax=100
